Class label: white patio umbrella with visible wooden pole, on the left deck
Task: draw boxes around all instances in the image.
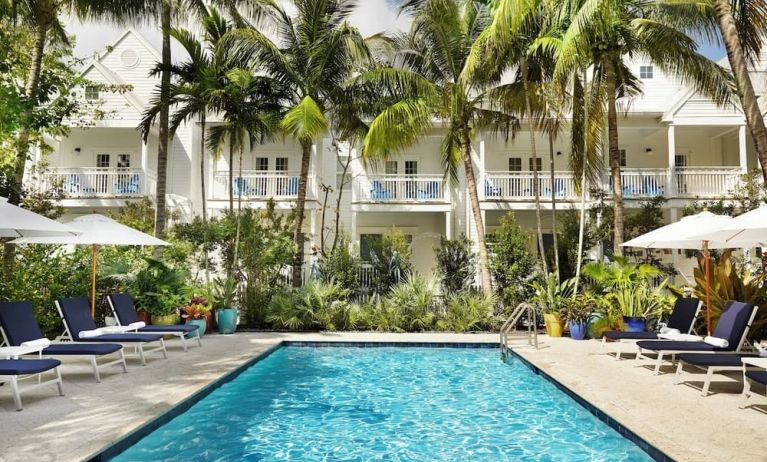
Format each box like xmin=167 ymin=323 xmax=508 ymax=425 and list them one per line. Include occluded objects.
xmin=11 ymin=214 xmax=170 ymax=316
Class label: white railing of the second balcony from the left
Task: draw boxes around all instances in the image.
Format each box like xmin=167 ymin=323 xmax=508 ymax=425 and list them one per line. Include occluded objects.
xmin=212 ymin=170 xmax=313 ymax=200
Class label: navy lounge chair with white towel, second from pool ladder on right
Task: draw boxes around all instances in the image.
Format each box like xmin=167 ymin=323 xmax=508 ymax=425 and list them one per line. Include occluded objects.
xmin=636 ymin=301 xmax=757 ymax=374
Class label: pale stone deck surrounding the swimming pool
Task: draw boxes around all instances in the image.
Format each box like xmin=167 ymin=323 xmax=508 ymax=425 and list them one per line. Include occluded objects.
xmin=0 ymin=333 xmax=767 ymax=462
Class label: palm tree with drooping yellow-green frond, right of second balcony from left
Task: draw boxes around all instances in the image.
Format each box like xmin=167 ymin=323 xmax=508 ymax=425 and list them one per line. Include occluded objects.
xmin=225 ymin=0 xmax=370 ymax=286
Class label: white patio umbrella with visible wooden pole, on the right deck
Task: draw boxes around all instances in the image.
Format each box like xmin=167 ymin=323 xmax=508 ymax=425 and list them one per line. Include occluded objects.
xmin=623 ymin=211 xmax=732 ymax=335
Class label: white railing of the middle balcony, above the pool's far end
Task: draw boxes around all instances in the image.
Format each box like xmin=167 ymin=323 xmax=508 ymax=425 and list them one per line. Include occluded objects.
xmin=354 ymin=175 xmax=448 ymax=202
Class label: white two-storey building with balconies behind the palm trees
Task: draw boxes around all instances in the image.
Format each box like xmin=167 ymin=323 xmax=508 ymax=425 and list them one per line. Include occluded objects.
xmin=28 ymin=30 xmax=767 ymax=282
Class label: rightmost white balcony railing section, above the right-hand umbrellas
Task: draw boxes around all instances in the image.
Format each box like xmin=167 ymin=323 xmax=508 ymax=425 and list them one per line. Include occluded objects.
xmin=675 ymin=167 xmax=743 ymax=198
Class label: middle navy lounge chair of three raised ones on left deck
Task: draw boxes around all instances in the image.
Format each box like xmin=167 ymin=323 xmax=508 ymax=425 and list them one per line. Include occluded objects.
xmin=56 ymin=298 xmax=168 ymax=366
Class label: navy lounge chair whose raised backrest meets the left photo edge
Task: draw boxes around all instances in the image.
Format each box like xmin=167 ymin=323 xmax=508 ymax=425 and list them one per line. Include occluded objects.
xmin=0 ymin=302 xmax=128 ymax=382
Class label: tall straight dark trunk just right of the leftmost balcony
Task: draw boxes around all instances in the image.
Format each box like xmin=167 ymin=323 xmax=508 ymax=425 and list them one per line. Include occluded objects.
xmin=154 ymin=0 xmax=172 ymax=251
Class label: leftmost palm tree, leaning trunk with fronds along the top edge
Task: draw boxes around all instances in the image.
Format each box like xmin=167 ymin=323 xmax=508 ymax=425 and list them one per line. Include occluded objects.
xmin=0 ymin=0 xmax=156 ymax=204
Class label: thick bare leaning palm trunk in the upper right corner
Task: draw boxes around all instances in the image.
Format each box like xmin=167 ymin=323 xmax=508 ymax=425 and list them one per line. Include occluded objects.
xmin=714 ymin=0 xmax=767 ymax=185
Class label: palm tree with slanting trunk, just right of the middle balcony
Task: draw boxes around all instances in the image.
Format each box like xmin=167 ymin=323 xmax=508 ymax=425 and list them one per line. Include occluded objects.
xmin=354 ymin=0 xmax=518 ymax=292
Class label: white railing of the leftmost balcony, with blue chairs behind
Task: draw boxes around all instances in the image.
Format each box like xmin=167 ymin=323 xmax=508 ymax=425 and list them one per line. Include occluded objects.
xmin=40 ymin=168 xmax=150 ymax=198
